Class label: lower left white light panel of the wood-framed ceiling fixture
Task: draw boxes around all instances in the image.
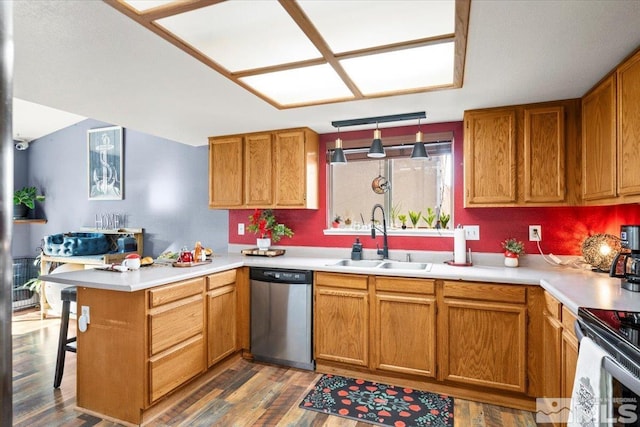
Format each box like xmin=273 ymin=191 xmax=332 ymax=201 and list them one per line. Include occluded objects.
xmin=240 ymin=64 xmax=353 ymax=106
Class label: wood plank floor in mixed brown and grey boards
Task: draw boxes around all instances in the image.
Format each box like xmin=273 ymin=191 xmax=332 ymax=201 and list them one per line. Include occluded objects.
xmin=12 ymin=311 xmax=536 ymax=427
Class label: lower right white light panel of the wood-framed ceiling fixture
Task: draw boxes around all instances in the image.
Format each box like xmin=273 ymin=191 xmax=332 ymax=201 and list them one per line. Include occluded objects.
xmin=340 ymin=43 xmax=454 ymax=95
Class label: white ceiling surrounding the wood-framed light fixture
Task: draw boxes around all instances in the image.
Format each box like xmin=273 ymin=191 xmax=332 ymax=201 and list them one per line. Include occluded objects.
xmin=14 ymin=0 xmax=640 ymax=146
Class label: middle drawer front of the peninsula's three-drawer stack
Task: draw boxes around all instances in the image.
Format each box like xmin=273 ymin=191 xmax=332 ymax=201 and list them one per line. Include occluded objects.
xmin=149 ymin=294 xmax=204 ymax=355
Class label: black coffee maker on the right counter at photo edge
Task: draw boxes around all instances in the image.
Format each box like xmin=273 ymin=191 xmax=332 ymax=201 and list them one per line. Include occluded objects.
xmin=609 ymin=225 xmax=640 ymax=292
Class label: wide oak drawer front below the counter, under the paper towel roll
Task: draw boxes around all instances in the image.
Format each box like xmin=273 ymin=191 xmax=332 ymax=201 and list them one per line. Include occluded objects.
xmin=443 ymin=281 xmax=526 ymax=304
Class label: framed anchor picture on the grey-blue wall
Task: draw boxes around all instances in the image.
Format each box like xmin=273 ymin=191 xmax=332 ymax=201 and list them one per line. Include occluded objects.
xmin=87 ymin=126 xmax=124 ymax=200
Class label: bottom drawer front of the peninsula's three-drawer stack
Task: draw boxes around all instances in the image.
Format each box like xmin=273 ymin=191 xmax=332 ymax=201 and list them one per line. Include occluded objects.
xmin=149 ymin=334 xmax=205 ymax=402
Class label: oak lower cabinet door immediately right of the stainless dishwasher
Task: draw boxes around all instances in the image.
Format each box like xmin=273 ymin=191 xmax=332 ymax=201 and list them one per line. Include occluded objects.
xmin=313 ymin=286 xmax=369 ymax=367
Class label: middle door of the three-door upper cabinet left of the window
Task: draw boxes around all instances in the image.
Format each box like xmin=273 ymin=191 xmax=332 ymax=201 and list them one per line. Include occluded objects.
xmin=244 ymin=133 xmax=273 ymax=207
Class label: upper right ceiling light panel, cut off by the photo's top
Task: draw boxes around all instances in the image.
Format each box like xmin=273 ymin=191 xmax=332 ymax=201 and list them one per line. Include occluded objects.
xmin=298 ymin=0 xmax=455 ymax=53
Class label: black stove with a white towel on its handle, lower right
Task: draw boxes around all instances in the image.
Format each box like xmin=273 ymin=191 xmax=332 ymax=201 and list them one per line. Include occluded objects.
xmin=575 ymin=307 xmax=640 ymax=426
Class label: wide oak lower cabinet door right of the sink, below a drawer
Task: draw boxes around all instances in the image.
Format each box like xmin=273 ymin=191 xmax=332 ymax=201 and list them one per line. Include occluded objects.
xmin=439 ymin=300 xmax=527 ymax=392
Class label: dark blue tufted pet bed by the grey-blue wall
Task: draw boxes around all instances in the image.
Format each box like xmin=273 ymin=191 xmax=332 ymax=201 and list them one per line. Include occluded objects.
xmin=42 ymin=233 xmax=109 ymax=256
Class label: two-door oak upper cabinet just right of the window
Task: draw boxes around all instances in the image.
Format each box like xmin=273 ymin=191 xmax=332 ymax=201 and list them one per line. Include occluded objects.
xmin=464 ymin=99 xmax=581 ymax=207
